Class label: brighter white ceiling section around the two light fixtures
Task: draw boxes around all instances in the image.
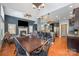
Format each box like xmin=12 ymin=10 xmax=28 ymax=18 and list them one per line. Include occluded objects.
xmin=2 ymin=3 xmax=70 ymax=19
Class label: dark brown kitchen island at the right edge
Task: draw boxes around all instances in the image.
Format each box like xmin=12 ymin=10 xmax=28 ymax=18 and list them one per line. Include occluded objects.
xmin=67 ymin=35 xmax=79 ymax=52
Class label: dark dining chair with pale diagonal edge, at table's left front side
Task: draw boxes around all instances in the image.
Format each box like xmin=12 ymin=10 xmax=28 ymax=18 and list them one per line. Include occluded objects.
xmin=13 ymin=37 xmax=29 ymax=56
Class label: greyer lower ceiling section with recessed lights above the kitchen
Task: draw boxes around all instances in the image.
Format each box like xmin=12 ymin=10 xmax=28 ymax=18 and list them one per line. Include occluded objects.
xmin=44 ymin=3 xmax=79 ymax=22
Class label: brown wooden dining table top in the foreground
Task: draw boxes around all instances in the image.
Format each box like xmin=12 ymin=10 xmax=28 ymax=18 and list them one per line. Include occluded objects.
xmin=17 ymin=37 xmax=43 ymax=53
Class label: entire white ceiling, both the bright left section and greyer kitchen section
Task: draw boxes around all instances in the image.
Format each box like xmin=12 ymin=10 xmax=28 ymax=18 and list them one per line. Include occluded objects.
xmin=2 ymin=3 xmax=79 ymax=21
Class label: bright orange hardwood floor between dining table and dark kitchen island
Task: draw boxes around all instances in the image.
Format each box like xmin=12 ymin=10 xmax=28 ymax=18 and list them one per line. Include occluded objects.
xmin=48 ymin=37 xmax=79 ymax=56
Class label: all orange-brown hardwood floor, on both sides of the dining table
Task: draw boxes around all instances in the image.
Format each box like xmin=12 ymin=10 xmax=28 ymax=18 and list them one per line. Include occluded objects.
xmin=0 ymin=37 xmax=79 ymax=56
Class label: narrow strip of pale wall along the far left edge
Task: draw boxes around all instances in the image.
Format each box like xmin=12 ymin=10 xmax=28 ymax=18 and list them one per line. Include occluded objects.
xmin=0 ymin=5 xmax=5 ymax=48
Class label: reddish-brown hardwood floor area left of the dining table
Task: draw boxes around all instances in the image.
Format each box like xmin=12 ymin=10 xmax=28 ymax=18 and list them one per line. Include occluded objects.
xmin=0 ymin=43 xmax=16 ymax=56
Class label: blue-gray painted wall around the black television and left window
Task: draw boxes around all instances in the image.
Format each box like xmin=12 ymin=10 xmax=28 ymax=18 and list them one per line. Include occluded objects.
xmin=5 ymin=15 xmax=34 ymax=35
